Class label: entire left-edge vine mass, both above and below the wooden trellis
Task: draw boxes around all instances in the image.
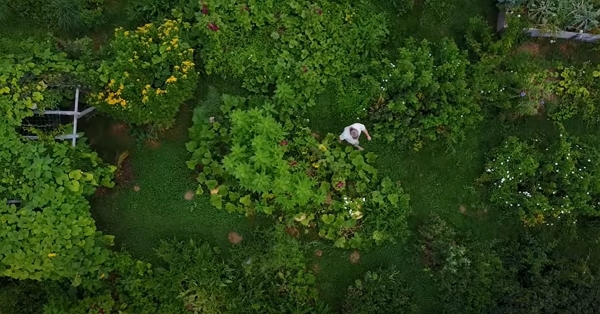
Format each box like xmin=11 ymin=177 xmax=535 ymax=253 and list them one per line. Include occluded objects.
xmin=0 ymin=39 xmax=114 ymax=285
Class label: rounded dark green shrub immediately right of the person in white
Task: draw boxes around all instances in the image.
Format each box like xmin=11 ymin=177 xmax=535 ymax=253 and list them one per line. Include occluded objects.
xmin=370 ymin=39 xmax=481 ymax=149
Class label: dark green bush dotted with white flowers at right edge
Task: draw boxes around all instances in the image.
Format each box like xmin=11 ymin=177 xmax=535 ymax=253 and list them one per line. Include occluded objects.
xmin=480 ymin=127 xmax=600 ymax=226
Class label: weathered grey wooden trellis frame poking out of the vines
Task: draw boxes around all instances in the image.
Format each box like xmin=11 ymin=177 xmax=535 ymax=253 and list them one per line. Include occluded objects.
xmin=23 ymin=88 xmax=96 ymax=147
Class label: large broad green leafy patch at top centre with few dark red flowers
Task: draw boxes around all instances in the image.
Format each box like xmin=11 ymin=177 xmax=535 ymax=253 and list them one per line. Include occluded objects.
xmin=195 ymin=0 xmax=388 ymax=114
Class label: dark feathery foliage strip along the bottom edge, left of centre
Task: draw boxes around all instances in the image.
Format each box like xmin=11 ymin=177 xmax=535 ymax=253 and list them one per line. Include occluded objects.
xmin=45 ymin=228 xmax=328 ymax=314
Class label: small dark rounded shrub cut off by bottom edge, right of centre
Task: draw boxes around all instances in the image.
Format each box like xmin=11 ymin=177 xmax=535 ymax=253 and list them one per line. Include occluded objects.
xmin=342 ymin=268 xmax=417 ymax=314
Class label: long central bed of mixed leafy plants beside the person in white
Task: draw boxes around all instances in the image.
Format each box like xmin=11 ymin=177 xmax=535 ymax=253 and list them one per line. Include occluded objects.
xmin=187 ymin=95 xmax=408 ymax=247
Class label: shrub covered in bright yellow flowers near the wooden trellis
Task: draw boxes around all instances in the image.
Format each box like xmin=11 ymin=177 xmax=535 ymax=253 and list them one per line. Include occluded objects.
xmin=91 ymin=20 xmax=198 ymax=128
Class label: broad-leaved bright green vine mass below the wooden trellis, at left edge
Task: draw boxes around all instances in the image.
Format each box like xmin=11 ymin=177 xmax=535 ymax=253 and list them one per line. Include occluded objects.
xmin=0 ymin=124 xmax=114 ymax=285
